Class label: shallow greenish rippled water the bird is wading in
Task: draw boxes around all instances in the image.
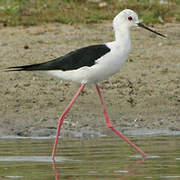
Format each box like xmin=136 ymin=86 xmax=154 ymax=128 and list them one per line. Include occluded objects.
xmin=0 ymin=135 xmax=180 ymax=180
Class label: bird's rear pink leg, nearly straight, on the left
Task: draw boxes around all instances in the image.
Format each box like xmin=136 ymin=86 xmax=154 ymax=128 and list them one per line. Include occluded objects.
xmin=52 ymin=84 xmax=86 ymax=160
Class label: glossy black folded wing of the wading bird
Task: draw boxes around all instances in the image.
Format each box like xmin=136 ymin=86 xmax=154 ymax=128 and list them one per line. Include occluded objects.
xmin=7 ymin=44 xmax=110 ymax=71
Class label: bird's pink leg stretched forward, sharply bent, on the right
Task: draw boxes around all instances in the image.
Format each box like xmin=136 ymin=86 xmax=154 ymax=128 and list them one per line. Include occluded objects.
xmin=96 ymin=84 xmax=146 ymax=157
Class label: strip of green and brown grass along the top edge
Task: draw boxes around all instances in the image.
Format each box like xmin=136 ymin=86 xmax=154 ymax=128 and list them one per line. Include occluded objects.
xmin=0 ymin=0 xmax=180 ymax=26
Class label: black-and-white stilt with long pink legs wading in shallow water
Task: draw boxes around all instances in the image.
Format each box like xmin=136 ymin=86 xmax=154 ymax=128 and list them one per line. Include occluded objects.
xmin=7 ymin=9 xmax=166 ymax=160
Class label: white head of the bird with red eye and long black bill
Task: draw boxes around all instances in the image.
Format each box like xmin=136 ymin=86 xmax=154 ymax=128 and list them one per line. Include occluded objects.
xmin=113 ymin=9 xmax=166 ymax=37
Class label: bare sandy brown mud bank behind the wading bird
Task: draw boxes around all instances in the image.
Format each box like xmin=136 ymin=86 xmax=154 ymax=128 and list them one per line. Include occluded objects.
xmin=0 ymin=22 xmax=180 ymax=136
